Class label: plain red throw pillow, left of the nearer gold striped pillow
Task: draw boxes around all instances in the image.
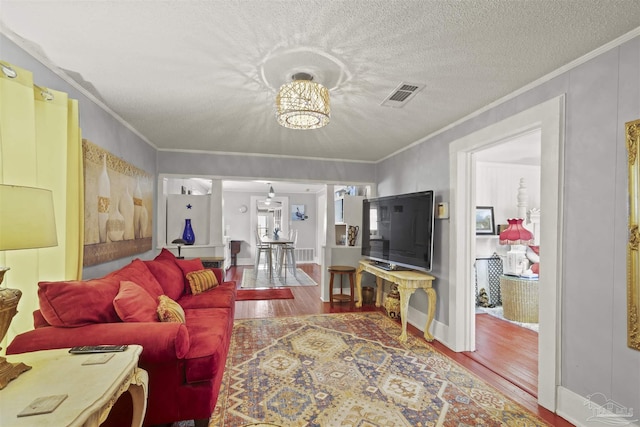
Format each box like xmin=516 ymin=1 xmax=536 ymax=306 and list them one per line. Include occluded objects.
xmin=113 ymin=280 xmax=158 ymax=322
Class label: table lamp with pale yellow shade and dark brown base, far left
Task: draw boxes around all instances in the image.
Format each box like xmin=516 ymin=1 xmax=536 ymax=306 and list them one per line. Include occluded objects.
xmin=0 ymin=184 xmax=58 ymax=389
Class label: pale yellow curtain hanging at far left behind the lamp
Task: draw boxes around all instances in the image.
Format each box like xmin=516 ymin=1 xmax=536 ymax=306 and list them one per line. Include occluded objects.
xmin=0 ymin=61 xmax=83 ymax=341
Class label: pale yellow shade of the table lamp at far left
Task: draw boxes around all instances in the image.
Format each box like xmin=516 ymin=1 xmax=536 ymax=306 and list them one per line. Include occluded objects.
xmin=0 ymin=184 xmax=58 ymax=251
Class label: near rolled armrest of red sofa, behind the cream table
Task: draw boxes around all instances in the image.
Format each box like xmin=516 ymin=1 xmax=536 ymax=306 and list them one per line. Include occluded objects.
xmin=7 ymin=322 xmax=190 ymax=363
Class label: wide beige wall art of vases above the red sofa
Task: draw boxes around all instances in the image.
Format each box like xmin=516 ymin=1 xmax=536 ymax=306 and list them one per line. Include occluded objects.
xmin=82 ymin=139 xmax=153 ymax=266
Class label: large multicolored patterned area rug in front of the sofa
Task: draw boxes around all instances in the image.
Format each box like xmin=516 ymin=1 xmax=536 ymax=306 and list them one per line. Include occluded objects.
xmin=210 ymin=312 xmax=548 ymax=427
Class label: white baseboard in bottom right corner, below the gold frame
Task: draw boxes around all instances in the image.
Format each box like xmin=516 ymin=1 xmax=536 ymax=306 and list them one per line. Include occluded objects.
xmin=557 ymin=387 xmax=639 ymax=427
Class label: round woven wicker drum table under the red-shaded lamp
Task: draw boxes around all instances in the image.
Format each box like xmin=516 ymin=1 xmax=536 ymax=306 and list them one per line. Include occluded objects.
xmin=500 ymin=276 xmax=538 ymax=323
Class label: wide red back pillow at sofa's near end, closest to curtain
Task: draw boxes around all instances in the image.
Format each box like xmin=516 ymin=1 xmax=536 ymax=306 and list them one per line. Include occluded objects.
xmin=38 ymin=277 xmax=120 ymax=327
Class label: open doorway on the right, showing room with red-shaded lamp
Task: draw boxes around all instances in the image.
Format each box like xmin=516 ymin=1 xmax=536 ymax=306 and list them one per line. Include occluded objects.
xmin=465 ymin=129 xmax=544 ymax=396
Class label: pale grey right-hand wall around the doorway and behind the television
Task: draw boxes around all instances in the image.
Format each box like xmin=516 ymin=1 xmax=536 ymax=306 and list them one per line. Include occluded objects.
xmin=376 ymin=37 xmax=640 ymax=409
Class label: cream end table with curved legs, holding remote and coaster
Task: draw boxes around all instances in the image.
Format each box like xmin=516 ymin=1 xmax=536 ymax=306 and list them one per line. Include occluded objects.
xmin=0 ymin=345 xmax=149 ymax=427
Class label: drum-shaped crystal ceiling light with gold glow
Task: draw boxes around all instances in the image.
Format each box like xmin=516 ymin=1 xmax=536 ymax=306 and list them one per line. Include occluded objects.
xmin=276 ymin=73 xmax=331 ymax=129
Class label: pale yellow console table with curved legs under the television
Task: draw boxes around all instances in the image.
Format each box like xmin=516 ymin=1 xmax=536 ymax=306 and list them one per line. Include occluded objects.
xmin=356 ymin=260 xmax=436 ymax=342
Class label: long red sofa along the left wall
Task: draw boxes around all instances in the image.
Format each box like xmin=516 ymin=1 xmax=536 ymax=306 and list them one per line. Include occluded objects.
xmin=7 ymin=250 xmax=236 ymax=425
